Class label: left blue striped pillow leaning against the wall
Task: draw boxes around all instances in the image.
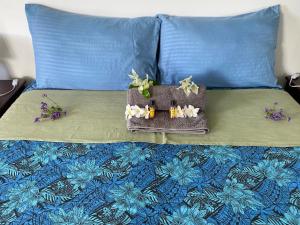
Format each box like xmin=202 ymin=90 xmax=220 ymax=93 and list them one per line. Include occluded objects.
xmin=25 ymin=4 xmax=160 ymax=90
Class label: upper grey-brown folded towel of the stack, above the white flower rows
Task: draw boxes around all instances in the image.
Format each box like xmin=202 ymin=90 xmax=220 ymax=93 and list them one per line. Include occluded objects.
xmin=127 ymin=86 xmax=206 ymax=111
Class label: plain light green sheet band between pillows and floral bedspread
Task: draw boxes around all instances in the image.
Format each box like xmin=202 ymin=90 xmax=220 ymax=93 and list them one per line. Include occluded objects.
xmin=0 ymin=89 xmax=300 ymax=147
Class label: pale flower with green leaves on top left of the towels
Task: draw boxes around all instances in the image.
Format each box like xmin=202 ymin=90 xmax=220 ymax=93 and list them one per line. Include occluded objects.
xmin=128 ymin=69 xmax=156 ymax=98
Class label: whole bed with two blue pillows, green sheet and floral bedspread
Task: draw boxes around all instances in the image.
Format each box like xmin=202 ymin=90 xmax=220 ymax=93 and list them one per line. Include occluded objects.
xmin=0 ymin=4 xmax=300 ymax=225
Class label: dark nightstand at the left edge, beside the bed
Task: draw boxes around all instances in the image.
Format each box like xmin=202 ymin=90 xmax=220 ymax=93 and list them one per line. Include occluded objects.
xmin=0 ymin=79 xmax=25 ymax=118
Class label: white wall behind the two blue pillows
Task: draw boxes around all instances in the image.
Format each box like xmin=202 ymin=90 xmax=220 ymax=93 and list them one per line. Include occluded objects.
xmin=0 ymin=0 xmax=300 ymax=81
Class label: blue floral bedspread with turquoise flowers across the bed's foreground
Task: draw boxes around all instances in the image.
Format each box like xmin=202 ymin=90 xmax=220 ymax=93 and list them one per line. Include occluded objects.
xmin=0 ymin=141 xmax=300 ymax=225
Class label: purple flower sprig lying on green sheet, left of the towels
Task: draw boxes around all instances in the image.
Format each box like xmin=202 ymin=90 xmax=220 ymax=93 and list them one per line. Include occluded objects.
xmin=34 ymin=94 xmax=67 ymax=123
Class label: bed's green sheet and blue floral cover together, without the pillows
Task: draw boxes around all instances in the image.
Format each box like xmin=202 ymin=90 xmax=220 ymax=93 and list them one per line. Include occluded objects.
xmin=0 ymin=89 xmax=300 ymax=224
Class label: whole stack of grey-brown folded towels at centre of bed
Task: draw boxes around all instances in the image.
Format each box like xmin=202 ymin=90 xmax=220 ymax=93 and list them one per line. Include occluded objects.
xmin=127 ymin=86 xmax=208 ymax=134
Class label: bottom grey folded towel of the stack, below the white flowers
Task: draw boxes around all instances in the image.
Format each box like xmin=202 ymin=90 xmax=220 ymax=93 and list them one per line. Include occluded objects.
xmin=127 ymin=111 xmax=208 ymax=134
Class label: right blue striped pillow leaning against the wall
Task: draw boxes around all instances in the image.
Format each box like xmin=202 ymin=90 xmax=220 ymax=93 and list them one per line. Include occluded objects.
xmin=158 ymin=5 xmax=280 ymax=88
